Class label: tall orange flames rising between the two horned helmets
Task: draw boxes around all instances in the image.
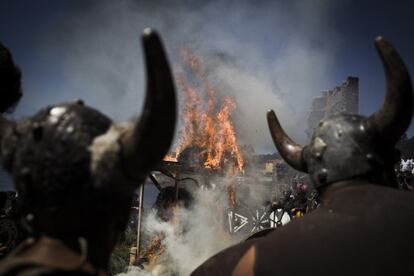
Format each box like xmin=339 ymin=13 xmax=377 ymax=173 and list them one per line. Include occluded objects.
xmin=164 ymin=48 xmax=244 ymax=171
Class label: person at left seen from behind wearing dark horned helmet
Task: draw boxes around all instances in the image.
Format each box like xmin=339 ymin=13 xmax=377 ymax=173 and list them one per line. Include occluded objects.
xmin=0 ymin=29 xmax=176 ymax=275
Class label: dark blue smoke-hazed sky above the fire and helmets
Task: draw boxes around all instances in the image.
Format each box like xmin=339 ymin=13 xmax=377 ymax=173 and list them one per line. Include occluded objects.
xmin=0 ymin=0 xmax=414 ymax=152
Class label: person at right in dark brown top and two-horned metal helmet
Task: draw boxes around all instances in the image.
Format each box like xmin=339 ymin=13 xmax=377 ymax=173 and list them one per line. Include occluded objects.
xmin=192 ymin=37 xmax=414 ymax=276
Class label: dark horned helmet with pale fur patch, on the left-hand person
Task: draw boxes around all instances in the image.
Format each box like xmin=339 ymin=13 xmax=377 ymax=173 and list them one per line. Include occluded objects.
xmin=0 ymin=29 xmax=176 ymax=234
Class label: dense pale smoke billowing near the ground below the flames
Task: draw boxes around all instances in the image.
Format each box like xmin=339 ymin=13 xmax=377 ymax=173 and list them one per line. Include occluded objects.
xmin=121 ymin=185 xmax=243 ymax=275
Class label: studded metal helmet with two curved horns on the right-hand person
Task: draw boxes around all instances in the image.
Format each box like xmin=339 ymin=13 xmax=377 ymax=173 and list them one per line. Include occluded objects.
xmin=267 ymin=37 xmax=413 ymax=188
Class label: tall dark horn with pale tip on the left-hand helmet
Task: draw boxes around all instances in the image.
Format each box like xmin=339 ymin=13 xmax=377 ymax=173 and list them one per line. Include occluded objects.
xmin=121 ymin=28 xmax=176 ymax=177
